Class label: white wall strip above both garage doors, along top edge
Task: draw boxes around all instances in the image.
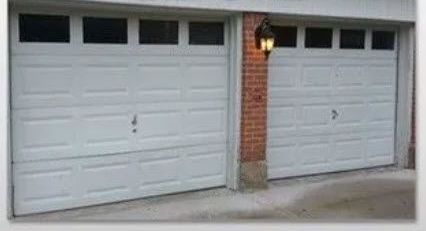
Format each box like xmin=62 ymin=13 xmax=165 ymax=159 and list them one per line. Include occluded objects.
xmin=9 ymin=0 xmax=416 ymax=22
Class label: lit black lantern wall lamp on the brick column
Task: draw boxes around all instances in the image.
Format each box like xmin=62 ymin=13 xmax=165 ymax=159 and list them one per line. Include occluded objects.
xmin=255 ymin=18 xmax=275 ymax=58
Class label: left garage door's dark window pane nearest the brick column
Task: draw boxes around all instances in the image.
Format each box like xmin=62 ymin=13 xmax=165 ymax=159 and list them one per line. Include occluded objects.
xmin=189 ymin=22 xmax=224 ymax=45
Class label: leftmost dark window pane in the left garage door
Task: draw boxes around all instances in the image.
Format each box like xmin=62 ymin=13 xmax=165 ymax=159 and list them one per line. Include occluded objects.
xmin=19 ymin=14 xmax=70 ymax=43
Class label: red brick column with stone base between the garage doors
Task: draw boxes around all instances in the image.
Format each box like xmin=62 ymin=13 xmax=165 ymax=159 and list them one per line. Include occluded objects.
xmin=240 ymin=13 xmax=268 ymax=189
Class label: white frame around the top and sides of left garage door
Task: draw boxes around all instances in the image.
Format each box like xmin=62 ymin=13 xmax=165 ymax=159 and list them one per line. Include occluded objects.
xmin=6 ymin=2 xmax=242 ymax=218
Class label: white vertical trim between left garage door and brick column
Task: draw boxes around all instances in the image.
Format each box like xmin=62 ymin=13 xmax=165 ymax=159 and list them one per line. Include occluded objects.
xmin=226 ymin=14 xmax=243 ymax=190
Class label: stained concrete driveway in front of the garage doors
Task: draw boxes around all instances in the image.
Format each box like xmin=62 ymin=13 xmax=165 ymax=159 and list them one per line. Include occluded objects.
xmin=15 ymin=168 xmax=416 ymax=222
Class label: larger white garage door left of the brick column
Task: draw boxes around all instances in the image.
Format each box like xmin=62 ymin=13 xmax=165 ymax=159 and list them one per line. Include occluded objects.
xmin=11 ymin=11 xmax=228 ymax=215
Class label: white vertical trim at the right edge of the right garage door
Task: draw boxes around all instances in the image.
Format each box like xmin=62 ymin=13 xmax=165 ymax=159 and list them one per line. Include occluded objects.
xmin=395 ymin=25 xmax=414 ymax=168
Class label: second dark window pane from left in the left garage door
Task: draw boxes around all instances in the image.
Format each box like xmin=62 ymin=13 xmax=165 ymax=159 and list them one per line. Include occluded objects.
xmin=83 ymin=17 xmax=127 ymax=43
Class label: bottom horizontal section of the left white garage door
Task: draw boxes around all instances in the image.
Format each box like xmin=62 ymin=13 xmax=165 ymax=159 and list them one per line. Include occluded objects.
xmin=14 ymin=144 xmax=225 ymax=214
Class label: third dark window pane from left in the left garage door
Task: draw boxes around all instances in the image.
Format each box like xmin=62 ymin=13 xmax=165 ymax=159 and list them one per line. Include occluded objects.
xmin=139 ymin=20 xmax=178 ymax=44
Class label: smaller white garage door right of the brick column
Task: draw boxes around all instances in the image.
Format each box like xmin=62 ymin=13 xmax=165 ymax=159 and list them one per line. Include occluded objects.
xmin=267 ymin=24 xmax=397 ymax=179
